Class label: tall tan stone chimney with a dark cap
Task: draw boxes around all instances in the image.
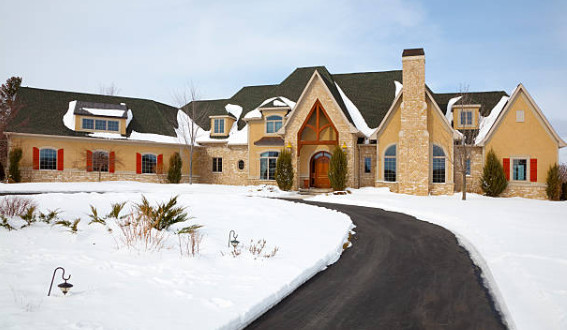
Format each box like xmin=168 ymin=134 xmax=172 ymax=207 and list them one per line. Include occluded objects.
xmin=397 ymin=48 xmax=430 ymax=195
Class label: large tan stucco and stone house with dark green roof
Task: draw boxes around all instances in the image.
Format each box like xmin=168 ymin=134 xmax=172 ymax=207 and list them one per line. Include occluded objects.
xmin=6 ymin=49 xmax=566 ymax=198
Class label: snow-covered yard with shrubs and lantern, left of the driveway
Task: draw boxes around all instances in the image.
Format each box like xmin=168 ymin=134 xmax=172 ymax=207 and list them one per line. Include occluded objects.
xmin=0 ymin=182 xmax=352 ymax=329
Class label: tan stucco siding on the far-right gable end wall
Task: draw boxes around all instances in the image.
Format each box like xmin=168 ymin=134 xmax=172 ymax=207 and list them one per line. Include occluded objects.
xmin=484 ymin=92 xmax=558 ymax=184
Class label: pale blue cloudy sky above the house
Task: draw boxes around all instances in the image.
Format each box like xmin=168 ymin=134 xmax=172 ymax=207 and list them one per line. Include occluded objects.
xmin=0 ymin=0 xmax=567 ymax=136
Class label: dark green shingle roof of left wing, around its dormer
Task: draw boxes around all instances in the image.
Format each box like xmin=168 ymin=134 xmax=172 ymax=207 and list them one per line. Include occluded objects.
xmin=6 ymin=87 xmax=177 ymax=136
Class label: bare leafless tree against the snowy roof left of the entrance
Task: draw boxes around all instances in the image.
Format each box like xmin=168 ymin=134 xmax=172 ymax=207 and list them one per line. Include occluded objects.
xmin=174 ymin=84 xmax=209 ymax=184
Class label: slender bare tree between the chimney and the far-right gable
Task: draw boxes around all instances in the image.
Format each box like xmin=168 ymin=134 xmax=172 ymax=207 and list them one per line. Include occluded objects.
xmin=453 ymin=85 xmax=480 ymax=200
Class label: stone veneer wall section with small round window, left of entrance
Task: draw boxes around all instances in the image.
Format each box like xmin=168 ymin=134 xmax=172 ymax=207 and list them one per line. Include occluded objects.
xmin=195 ymin=144 xmax=248 ymax=185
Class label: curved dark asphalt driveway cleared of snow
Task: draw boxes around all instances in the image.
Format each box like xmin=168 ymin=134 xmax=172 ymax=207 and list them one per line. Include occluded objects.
xmin=248 ymin=202 xmax=506 ymax=329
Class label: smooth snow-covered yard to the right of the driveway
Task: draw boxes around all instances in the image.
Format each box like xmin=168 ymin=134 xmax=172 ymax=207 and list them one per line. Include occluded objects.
xmin=311 ymin=188 xmax=567 ymax=329
